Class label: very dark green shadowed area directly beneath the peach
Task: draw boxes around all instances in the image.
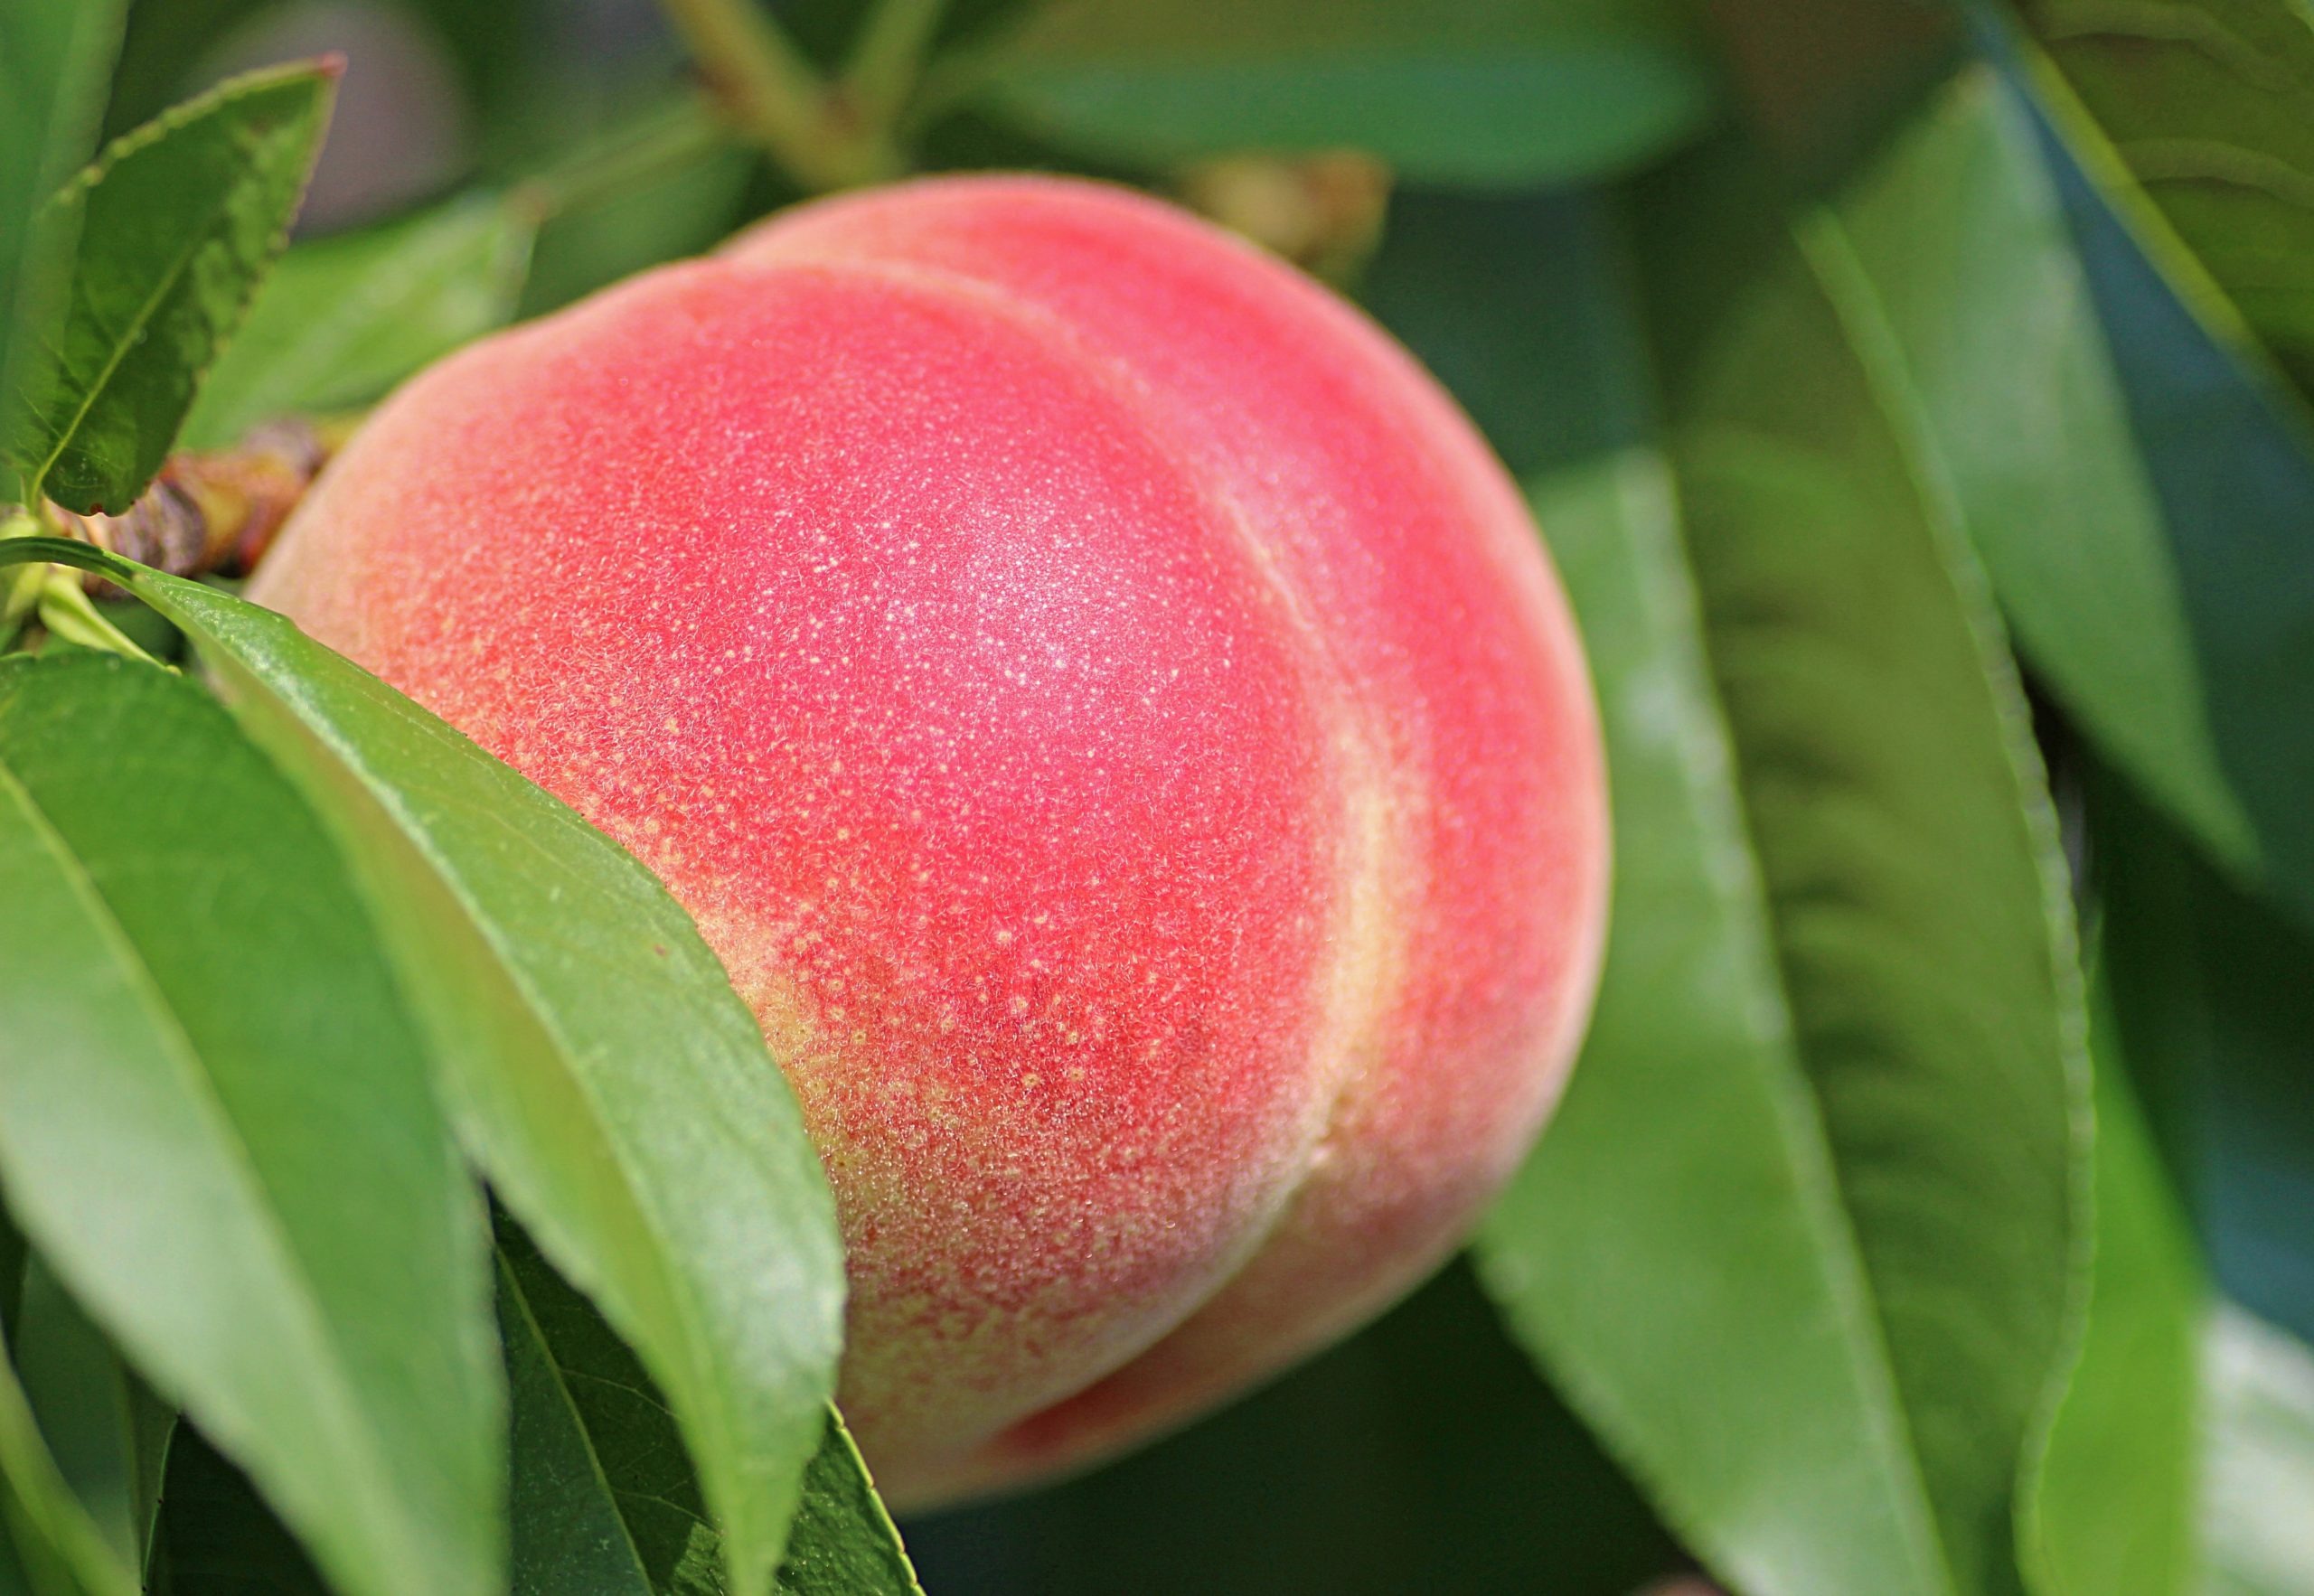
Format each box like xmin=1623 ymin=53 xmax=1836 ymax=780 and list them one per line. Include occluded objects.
xmin=908 ymin=1263 xmax=1685 ymax=1596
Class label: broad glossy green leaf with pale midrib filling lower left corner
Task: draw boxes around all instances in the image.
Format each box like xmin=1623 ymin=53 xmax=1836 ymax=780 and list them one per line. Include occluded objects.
xmin=0 ymin=654 xmax=503 ymax=1596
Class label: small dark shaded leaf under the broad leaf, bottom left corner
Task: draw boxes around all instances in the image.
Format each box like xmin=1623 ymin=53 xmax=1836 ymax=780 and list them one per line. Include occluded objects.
xmin=12 ymin=1258 xmax=174 ymax=1571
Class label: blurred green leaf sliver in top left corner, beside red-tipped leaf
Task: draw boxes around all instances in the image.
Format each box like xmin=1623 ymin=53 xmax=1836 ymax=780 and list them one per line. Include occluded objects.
xmin=0 ymin=0 xmax=127 ymax=485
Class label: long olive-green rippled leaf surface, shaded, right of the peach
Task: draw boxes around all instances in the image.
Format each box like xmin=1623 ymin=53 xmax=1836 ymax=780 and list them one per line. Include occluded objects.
xmin=1675 ymin=186 xmax=2087 ymax=1591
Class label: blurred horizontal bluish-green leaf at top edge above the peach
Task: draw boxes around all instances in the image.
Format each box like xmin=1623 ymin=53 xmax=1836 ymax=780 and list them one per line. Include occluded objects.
xmin=992 ymin=0 xmax=1717 ymax=185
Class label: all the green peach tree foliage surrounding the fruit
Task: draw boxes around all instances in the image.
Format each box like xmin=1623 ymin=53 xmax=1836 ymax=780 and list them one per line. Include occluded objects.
xmin=0 ymin=0 xmax=2314 ymax=1596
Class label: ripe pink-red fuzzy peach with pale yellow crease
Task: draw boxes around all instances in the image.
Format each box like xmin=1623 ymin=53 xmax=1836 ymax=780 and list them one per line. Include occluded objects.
xmin=257 ymin=178 xmax=1606 ymax=1504
